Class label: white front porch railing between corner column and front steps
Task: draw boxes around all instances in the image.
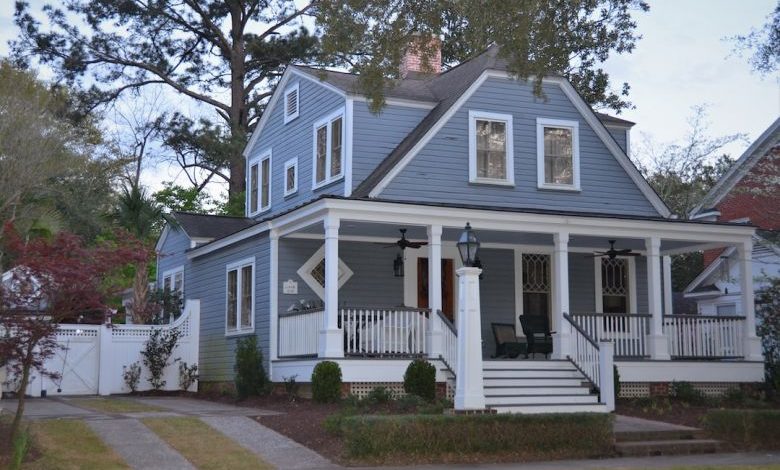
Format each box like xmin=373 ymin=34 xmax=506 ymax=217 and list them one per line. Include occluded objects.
xmin=339 ymin=308 xmax=430 ymax=356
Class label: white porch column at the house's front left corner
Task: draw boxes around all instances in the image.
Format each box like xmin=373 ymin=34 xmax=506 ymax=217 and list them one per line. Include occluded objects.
xmin=319 ymin=215 xmax=344 ymax=357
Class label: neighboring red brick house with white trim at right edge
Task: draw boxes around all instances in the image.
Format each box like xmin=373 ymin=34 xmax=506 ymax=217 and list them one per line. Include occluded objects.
xmin=684 ymin=118 xmax=780 ymax=316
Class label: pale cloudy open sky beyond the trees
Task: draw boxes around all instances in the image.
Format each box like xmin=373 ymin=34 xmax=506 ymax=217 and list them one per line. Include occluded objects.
xmin=0 ymin=0 xmax=780 ymax=192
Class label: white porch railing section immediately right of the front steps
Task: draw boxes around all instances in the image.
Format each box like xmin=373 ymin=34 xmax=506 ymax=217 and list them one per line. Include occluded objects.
xmin=571 ymin=313 xmax=651 ymax=358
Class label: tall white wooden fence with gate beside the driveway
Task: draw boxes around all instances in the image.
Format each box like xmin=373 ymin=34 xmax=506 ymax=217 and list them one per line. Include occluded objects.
xmin=3 ymin=300 xmax=200 ymax=396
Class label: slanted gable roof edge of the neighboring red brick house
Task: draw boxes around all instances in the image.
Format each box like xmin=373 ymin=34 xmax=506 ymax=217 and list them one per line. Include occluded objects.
xmin=690 ymin=117 xmax=780 ymax=216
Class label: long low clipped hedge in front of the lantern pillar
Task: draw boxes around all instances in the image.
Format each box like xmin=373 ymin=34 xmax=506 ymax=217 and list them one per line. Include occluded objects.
xmin=330 ymin=413 xmax=613 ymax=463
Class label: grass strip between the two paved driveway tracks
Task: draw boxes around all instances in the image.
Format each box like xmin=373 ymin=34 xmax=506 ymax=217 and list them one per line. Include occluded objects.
xmin=142 ymin=417 xmax=273 ymax=470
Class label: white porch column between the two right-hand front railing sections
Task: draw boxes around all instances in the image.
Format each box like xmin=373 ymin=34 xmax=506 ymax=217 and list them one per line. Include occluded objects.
xmin=645 ymin=237 xmax=670 ymax=360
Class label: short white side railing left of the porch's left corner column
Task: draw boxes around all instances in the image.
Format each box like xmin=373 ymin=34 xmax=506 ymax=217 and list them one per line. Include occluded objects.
xmin=278 ymin=309 xmax=325 ymax=357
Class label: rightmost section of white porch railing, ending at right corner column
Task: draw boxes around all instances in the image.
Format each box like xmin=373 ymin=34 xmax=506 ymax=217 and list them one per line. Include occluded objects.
xmin=663 ymin=315 xmax=745 ymax=359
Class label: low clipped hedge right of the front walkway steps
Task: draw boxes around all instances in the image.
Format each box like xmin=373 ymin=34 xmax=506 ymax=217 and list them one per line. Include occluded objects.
xmin=704 ymin=410 xmax=780 ymax=450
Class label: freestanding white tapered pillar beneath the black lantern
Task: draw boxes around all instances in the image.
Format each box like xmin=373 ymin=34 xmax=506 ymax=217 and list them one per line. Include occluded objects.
xmin=455 ymin=266 xmax=485 ymax=410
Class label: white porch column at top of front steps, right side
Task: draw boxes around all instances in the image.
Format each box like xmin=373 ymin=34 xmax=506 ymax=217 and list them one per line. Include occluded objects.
xmin=550 ymin=232 xmax=571 ymax=359
